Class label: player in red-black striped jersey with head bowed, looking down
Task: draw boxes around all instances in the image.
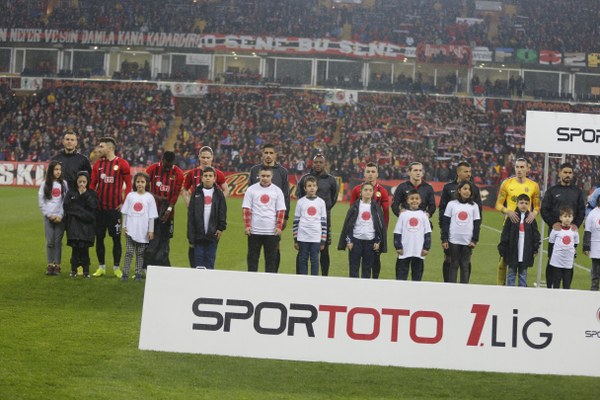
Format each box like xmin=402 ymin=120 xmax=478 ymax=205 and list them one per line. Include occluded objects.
xmin=144 ymin=151 xmax=183 ymax=268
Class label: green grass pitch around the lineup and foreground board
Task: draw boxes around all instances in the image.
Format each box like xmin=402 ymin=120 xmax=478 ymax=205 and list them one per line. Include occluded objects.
xmin=0 ymin=188 xmax=600 ymax=400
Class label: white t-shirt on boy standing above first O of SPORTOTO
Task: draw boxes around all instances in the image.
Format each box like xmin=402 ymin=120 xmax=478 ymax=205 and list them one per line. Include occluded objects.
xmin=242 ymin=182 xmax=286 ymax=235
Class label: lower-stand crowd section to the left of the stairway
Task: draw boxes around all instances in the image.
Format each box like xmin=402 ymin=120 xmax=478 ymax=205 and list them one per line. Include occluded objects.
xmin=0 ymin=83 xmax=175 ymax=166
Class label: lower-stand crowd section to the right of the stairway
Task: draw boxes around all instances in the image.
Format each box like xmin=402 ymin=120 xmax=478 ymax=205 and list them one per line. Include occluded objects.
xmin=171 ymin=87 xmax=600 ymax=190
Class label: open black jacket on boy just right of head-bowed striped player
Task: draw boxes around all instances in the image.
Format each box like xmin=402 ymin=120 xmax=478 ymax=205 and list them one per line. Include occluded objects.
xmin=188 ymin=184 xmax=227 ymax=244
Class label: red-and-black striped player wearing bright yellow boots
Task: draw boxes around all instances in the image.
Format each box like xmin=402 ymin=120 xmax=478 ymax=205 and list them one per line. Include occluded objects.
xmin=90 ymin=137 xmax=131 ymax=279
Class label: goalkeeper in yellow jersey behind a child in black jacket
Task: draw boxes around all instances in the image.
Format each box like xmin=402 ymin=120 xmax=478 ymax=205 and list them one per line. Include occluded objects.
xmin=496 ymin=158 xmax=541 ymax=285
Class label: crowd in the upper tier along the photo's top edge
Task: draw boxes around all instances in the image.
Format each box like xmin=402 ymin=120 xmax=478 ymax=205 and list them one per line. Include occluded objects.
xmin=0 ymin=0 xmax=600 ymax=51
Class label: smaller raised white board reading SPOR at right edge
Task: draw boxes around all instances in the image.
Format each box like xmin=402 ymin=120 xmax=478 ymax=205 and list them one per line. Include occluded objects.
xmin=525 ymin=111 xmax=600 ymax=156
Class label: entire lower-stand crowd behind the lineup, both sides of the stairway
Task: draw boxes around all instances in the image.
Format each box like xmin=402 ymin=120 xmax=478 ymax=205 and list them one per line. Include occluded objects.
xmin=0 ymin=79 xmax=600 ymax=190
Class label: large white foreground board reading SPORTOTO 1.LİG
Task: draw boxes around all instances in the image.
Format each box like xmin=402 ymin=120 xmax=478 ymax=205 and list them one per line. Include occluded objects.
xmin=139 ymin=267 xmax=600 ymax=376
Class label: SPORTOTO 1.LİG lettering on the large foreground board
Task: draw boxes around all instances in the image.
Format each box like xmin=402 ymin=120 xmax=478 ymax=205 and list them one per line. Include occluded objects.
xmin=192 ymin=297 xmax=553 ymax=350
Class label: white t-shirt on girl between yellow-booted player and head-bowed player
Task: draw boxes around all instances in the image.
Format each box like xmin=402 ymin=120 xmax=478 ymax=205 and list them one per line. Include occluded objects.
xmin=121 ymin=192 xmax=158 ymax=243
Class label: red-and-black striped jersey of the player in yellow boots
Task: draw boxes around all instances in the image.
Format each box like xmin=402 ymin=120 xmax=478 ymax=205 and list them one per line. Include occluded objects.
xmin=90 ymin=157 xmax=131 ymax=210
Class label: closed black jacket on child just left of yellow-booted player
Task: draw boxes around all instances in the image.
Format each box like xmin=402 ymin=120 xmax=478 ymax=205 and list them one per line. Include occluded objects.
xmin=63 ymin=189 xmax=98 ymax=246
